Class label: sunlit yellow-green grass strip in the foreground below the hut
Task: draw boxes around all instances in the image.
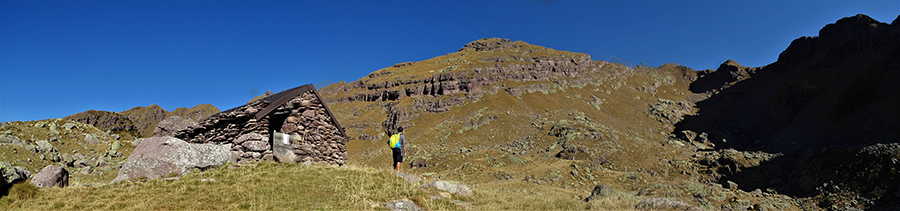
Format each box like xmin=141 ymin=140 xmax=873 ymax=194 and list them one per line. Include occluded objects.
xmin=0 ymin=162 xmax=636 ymax=210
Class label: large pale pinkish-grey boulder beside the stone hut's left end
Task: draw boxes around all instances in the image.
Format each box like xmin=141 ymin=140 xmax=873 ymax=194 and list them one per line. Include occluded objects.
xmin=113 ymin=136 xmax=234 ymax=183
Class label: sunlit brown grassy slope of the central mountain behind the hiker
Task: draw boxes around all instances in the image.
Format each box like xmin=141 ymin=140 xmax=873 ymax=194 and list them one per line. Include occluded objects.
xmin=320 ymin=39 xmax=797 ymax=210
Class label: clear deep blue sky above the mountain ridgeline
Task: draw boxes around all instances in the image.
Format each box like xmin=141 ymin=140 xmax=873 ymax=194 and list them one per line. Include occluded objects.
xmin=0 ymin=0 xmax=900 ymax=122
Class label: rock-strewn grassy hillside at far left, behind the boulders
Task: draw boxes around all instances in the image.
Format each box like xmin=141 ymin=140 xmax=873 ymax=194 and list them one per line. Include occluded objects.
xmin=0 ymin=119 xmax=135 ymax=186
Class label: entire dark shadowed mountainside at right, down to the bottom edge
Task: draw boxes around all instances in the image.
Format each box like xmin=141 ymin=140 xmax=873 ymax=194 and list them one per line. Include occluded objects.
xmin=675 ymin=14 xmax=900 ymax=209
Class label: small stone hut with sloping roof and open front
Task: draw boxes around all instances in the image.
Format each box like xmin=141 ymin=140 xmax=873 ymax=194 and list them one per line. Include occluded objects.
xmin=174 ymin=84 xmax=348 ymax=165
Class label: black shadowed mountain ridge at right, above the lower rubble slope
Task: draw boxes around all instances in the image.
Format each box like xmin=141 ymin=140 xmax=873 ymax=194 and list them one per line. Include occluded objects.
xmin=679 ymin=15 xmax=900 ymax=152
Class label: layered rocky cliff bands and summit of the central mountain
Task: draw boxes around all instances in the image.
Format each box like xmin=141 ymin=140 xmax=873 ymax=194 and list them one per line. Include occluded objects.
xmin=321 ymin=38 xmax=606 ymax=134
